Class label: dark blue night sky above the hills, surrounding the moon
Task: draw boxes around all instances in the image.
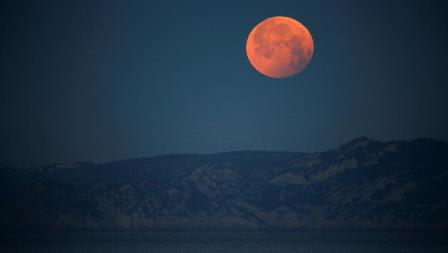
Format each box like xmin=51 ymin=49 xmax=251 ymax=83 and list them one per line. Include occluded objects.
xmin=0 ymin=0 xmax=448 ymax=165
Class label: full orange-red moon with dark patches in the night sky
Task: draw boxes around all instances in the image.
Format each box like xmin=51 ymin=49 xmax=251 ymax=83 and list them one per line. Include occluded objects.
xmin=246 ymin=16 xmax=314 ymax=78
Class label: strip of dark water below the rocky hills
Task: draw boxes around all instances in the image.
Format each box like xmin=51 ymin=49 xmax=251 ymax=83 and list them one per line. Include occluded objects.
xmin=0 ymin=231 xmax=448 ymax=253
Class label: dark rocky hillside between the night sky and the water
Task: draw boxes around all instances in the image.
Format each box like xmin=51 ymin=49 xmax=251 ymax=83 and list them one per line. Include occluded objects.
xmin=0 ymin=138 xmax=448 ymax=229
